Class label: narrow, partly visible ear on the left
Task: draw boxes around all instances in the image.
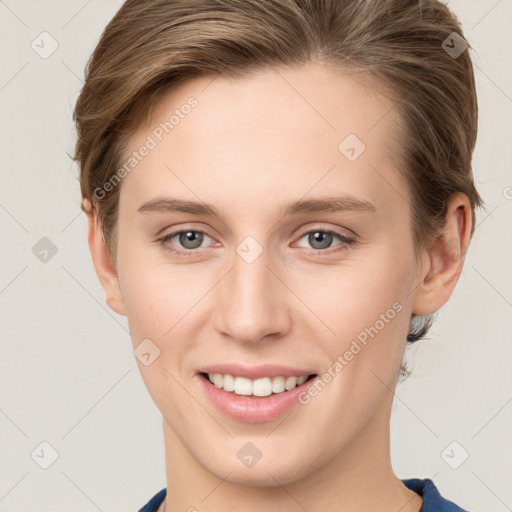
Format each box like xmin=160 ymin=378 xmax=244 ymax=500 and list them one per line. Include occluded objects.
xmin=83 ymin=199 xmax=126 ymax=315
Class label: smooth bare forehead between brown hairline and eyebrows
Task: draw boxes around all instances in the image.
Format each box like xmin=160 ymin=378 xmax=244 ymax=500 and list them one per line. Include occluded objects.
xmin=121 ymin=64 xmax=405 ymax=219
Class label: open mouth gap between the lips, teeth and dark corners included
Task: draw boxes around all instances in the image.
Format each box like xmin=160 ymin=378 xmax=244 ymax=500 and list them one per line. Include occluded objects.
xmin=199 ymin=372 xmax=318 ymax=399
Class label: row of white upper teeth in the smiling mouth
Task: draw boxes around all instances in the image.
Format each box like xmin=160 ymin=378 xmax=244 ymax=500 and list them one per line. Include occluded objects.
xmin=208 ymin=373 xmax=308 ymax=396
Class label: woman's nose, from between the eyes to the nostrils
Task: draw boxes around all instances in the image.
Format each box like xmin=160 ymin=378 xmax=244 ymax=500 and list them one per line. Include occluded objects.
xmin=214 ymin=243 xmax=291 ymax=344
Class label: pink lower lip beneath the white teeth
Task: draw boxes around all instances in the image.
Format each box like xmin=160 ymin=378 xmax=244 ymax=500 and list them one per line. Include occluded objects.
xmin=198 ymin=375 xmax=318 ymax=423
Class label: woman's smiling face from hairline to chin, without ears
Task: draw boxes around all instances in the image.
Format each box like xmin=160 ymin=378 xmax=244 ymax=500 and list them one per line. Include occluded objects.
xmin=108 ymin=64 xmax=424 ymax=485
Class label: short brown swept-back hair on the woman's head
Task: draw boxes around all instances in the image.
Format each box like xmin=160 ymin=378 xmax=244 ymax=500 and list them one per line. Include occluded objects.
xmin=74 ymin=0 xmax=484 ymax=341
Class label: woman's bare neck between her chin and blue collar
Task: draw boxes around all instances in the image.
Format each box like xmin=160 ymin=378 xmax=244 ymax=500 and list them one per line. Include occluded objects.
xmin=159 ymin=395 xmax=422 ymax=512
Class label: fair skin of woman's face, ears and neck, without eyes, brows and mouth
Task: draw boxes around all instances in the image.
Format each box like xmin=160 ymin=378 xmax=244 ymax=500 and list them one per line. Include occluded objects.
xmin=88 ymin=64 xmax=471 ymax=512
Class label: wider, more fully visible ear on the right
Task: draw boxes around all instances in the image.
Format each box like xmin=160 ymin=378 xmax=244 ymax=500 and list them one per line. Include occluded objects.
xmin=412 ymin=193 xmax=472 ymax=316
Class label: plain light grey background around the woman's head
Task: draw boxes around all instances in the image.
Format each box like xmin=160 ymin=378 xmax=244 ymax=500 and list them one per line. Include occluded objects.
xmin=0 ymin=0 xmax=512 ymax=512
